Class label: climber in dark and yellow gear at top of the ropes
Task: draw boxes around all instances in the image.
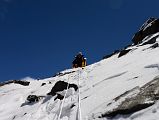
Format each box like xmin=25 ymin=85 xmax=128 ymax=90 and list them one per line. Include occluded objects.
xmin=72 ymin=52 xmax=87 ymax=68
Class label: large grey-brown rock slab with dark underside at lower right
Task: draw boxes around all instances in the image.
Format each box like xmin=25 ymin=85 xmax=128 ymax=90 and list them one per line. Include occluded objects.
xmin=99 ymin=78 xmax=159 ymax=117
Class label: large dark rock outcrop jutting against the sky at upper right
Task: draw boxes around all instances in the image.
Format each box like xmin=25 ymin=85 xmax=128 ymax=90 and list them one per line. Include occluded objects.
xmin=132 ymin=18 xmax=159 ymax=45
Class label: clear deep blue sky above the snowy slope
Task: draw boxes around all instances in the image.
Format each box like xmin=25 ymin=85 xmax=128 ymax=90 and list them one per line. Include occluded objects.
xmin=0 ymin=0 xmax=159 ymax=81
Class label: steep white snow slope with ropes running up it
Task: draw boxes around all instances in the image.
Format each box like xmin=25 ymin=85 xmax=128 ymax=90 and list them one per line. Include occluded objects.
xmin=0 ymin=33 xmax=159 ymax=120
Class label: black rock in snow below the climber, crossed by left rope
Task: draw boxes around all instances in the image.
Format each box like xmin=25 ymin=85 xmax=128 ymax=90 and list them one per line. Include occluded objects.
xmin=47 ymin=81 xmax=78 ymax=96
